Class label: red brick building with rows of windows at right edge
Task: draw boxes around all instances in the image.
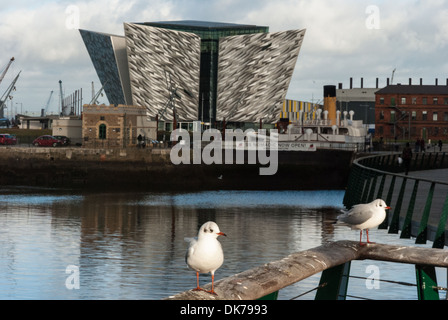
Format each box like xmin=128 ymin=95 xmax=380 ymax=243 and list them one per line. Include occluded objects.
xmin=375 ymin=83 xmax=448 ymax=141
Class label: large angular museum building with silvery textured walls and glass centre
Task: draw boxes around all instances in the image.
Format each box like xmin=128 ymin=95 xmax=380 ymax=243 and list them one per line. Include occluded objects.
xmin=80 ymin=21 xmax=305 ymax=123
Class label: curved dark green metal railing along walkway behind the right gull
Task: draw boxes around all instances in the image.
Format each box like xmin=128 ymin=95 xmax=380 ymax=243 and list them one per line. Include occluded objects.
xmin=343 ymin=152 xmax=448 ymax=248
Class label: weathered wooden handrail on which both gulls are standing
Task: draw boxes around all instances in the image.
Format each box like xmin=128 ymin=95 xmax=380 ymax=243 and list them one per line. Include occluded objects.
xmin=166 ymin=241 xmax=448 ymax=300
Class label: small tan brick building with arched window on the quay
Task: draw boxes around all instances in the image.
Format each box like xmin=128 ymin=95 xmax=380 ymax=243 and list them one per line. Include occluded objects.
xmin=82 ymin=105 xmax=157 ymax=148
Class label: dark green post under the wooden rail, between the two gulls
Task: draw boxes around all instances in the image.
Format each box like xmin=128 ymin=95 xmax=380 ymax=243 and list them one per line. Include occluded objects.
xmin=315 ymin=261 xmax=351 ymax=300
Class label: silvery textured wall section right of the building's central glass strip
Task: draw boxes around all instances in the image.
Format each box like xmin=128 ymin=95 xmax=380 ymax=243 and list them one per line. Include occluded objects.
xmin=217 ymin=29 xmax=306 ymax=123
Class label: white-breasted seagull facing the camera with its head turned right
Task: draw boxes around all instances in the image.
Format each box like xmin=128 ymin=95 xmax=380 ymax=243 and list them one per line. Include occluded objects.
xmin=185 ymin=221 xmax=227 ymax=295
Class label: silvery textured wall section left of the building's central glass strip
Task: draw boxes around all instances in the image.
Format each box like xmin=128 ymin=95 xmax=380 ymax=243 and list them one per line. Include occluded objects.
xmin=124 ymin=23 xmax=201 ymax=121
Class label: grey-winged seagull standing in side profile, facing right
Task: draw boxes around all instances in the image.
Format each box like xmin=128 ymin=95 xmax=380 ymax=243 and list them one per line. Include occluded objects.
xmin=337 ymin=199 xmax=390 ymax=246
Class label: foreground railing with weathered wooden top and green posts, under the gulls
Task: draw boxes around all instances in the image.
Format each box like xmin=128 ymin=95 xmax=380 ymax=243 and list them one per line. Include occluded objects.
xmin=167 ymin=241 xmax=448 ymax=300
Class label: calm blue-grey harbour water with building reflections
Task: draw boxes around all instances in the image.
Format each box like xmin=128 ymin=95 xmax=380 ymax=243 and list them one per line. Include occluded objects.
xmin=0 ymin=189 xmax=446 ymax=299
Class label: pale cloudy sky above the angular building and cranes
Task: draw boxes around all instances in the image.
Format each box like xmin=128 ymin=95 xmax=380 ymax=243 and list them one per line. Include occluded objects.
xmin=0 ymin=0 xmax=448 ymax=115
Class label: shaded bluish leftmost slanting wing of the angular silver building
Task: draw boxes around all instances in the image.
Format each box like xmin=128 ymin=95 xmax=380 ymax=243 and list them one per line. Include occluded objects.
xmin=79 ymin=30 xmax=126 ymax=105
